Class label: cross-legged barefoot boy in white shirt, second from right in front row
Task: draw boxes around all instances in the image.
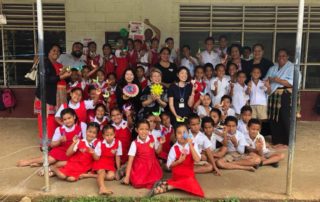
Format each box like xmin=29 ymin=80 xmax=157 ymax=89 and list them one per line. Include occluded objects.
xmin=217 ymin=116 xmax=261 ymax=172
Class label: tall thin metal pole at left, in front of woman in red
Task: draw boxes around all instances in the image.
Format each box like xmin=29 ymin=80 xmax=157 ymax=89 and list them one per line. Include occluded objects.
xmin=37 ymin=0 xmax=50 ymax=192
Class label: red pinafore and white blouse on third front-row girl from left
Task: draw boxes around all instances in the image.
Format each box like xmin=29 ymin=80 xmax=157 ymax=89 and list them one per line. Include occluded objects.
xmin=92 ymin=139 xmax=122 ymax=171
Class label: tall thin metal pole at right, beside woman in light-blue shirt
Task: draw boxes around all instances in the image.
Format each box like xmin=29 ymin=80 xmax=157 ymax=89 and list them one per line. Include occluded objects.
xmin=286 ymin=0 xmax=304 ymax=196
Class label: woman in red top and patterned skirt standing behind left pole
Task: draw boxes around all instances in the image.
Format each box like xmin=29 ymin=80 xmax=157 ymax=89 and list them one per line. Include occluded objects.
xmin=34 ymin=44 xmax=71 ymax=139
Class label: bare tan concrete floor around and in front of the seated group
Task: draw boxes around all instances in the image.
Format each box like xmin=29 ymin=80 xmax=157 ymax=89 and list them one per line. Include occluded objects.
xmin=0 ymin=119 xmax=320 ymax=201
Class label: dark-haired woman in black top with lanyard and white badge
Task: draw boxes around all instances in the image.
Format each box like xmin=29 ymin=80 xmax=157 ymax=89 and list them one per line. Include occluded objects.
xmin=168 ymin=66 xmax=196 ymax=123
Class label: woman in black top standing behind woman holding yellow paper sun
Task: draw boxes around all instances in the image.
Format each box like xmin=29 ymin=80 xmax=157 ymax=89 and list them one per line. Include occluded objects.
xmin=155 ymin=47 xmax=177 ymax=88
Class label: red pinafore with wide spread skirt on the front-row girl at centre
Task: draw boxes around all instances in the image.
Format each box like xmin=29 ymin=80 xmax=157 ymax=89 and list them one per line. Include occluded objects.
xmin=130 ymin=135 xmax=162 ymax=189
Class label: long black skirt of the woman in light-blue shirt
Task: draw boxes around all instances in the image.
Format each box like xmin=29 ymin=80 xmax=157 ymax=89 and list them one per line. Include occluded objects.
xmin=270 ymin=92 xmax=291 ymax=145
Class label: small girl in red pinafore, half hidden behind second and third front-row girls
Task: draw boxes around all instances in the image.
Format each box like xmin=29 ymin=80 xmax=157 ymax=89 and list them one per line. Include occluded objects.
xmin=88 ymin=103 xmax=109 ymax=140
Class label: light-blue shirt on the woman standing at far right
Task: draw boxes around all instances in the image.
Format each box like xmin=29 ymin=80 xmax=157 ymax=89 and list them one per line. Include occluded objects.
xmin=264 ymin=61 xmax=301 ymax=94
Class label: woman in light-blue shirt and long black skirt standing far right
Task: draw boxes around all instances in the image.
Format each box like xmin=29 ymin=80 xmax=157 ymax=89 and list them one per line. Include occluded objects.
xmin=265 ymin=49 xmax=294 ymax=145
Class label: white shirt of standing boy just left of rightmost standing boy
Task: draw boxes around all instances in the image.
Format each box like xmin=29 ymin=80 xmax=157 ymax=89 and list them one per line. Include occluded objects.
xmin=232 ymin=83 xmax=249 ymax=114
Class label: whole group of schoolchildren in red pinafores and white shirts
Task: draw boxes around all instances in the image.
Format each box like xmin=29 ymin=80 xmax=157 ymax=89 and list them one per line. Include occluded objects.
xmin=18 ymin=34 xmax=284 ymax=197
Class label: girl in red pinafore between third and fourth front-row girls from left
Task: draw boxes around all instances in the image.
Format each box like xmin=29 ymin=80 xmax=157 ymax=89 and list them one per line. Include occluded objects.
xmin=110 ymin=108 xmax=133 ymax=164
